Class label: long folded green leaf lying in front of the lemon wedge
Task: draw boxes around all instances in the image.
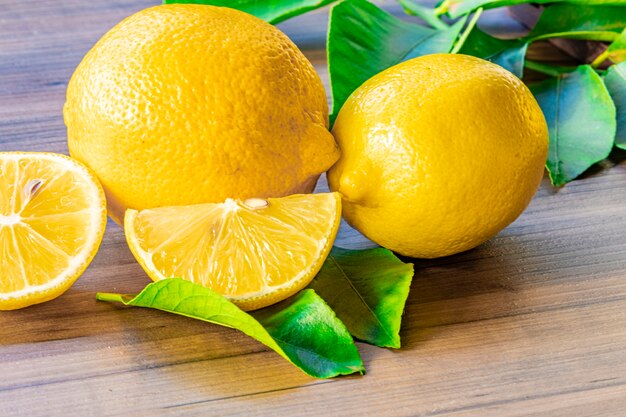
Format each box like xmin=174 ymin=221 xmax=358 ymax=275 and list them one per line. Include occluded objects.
xmin=96 ymin=278 xmax=364 ymax=378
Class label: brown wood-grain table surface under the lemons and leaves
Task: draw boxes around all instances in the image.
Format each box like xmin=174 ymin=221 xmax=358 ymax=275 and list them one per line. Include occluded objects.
xmin=0 ymin=0 xmax=626 ymax=417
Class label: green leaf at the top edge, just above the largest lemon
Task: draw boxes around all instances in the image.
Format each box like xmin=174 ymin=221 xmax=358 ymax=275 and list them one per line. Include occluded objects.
xmin=163 ymin=0 xmax=337 ymax=24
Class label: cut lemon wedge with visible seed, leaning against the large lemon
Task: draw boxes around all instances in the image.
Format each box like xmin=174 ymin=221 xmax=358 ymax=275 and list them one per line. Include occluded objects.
xmin=124 ymin=193 xmax=341 ymax=310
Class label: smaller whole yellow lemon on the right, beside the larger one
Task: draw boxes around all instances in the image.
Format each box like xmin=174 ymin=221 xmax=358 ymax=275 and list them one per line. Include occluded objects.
xmin=329 ymin=54 xmax=548 ymax=258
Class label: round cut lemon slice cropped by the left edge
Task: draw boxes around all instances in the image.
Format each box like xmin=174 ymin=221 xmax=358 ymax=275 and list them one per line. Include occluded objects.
xmin=0 ymin=152 xmax=106 ymax=310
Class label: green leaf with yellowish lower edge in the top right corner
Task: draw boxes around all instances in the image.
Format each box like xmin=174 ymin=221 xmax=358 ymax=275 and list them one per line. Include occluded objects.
xmin=526 ymin=3 xmax=626 ymax=42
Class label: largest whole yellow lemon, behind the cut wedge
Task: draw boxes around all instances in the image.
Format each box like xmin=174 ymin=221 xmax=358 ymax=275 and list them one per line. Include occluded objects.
xmin=64 ymin=4 xmax=339 ymax=223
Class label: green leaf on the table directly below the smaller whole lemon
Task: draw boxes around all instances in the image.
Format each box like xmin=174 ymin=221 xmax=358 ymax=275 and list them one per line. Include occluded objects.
xmin=309 ymin=247 xmax=413 ymax=348
